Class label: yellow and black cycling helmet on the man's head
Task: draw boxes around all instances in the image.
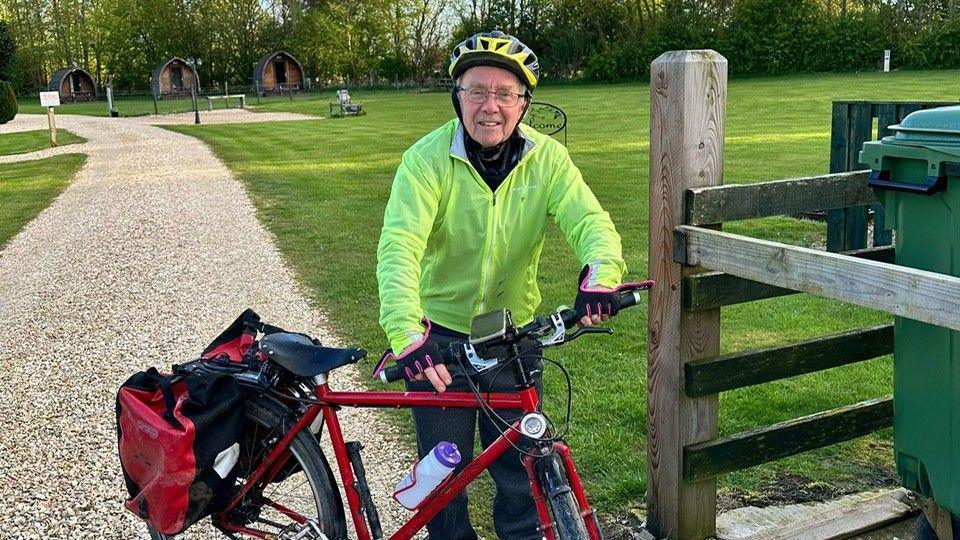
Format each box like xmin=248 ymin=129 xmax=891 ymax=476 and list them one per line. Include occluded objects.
xmin=449 ymin=30 xmax=540 ymax=91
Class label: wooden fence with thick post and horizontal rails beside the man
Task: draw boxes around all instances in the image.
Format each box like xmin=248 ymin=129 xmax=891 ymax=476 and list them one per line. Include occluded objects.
xmin=647 ymin=51 xmax=960 ymax=539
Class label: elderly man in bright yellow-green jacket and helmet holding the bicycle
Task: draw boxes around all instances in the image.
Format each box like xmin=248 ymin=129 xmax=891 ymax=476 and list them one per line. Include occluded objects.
xmin=377 ymin=31 xmax=625 ymax=540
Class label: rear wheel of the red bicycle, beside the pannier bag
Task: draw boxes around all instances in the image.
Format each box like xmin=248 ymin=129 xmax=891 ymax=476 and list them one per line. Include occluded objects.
xmin=149 ymin=396 xmax=347 ymax=540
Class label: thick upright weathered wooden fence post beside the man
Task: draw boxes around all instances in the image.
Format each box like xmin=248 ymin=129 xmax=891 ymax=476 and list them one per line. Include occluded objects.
xmin=647 ymin=50 xmax=727 ymax=539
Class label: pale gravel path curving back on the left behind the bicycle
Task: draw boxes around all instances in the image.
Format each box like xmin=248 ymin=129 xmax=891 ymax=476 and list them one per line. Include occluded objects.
xmin=0 ymin=113 xmax=413 ymax=539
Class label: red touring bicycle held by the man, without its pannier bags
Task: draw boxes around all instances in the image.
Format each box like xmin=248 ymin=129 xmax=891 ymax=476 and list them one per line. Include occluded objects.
xmin=154 ymin=282 xmax=652 ymax=540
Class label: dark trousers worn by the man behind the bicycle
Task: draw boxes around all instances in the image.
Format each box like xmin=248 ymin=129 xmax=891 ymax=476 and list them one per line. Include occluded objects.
xmin=407 ymin=325 xmax=543 ymax=540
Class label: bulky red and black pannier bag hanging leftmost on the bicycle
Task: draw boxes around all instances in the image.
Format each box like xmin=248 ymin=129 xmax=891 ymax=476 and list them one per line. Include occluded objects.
xmin=116 ymin=368 xmax=245 ymax=534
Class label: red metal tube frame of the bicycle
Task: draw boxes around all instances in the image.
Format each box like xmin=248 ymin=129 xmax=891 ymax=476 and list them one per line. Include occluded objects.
xmin=218 ymin=383 xmax=600 ymax=540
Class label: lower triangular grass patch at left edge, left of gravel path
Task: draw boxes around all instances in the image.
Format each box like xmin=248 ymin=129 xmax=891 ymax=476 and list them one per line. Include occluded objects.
xmin=0 ymin=154 xmax=87 ymax=247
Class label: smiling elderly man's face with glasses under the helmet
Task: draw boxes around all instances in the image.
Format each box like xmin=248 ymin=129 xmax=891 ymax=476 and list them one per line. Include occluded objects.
xmin=460 ymin=66 xmax=525 ymax=148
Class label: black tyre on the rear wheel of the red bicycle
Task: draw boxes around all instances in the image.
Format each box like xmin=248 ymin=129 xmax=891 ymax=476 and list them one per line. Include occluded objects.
xmin=147 ymin=396 xmax=347 ymax=540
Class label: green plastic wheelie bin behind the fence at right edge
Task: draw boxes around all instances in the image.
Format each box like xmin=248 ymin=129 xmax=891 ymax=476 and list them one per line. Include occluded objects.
xmin=860 ymin=106 xmax=960 ymax=516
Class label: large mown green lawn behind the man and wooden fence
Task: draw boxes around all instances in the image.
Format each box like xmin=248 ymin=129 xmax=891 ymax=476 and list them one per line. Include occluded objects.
xmin=171 ymin=71 xmax=960 ymax=528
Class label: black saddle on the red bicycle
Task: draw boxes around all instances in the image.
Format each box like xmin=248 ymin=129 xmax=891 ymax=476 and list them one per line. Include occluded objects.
xmin=260 ymin=332 xmax=367 ymax=377
